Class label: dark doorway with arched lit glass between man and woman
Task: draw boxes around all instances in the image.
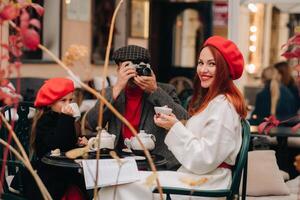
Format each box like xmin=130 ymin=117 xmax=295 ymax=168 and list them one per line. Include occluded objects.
xmin=149 ymin=0 xmax=212 ymax=82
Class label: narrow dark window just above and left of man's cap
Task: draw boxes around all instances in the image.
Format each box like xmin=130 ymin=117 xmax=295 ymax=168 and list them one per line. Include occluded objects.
xmin=91 ymin=0 xmax=116 ymax=64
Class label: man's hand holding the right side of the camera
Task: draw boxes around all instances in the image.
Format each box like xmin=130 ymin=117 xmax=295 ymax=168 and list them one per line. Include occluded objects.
xmin=134 ymin=72 xmax=157 ymax=93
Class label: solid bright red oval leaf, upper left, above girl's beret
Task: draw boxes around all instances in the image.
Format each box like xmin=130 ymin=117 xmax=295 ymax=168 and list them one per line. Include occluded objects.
xmin=21 ymin=29 xmax=40 ymax=50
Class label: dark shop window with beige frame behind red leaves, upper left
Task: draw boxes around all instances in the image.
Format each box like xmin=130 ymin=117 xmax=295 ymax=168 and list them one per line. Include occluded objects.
xmin=10 ymin=0 xmax=61 ymax=63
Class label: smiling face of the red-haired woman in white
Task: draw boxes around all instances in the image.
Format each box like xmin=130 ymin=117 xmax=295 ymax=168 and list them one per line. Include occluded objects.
xmin=197 ymin=47 xmax=216 ymax=88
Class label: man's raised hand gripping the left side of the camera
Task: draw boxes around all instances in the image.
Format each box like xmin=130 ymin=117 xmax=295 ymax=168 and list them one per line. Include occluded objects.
xmin=113 ymin=61 xmax=136 ymax=99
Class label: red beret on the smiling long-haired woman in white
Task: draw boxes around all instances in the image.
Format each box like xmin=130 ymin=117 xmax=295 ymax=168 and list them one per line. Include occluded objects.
xmin=204 ymin=36 xmax=244 ymax=80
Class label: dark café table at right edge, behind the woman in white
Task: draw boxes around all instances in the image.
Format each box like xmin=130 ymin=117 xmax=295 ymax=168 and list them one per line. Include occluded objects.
xmin=250 ymin=126 xmax=300 ymax=176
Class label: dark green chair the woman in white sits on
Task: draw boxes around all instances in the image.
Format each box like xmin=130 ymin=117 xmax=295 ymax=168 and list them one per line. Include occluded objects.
xmin=153 ymin=120 xmax=250 ymax=200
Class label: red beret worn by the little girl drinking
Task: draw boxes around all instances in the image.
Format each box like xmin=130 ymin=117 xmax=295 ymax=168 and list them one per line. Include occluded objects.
xmin=34 ymin=78 xmax=74 ymax=107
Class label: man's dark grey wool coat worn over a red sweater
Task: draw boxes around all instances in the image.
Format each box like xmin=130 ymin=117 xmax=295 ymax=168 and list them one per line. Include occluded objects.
xmin=87 ymin=83 xmax=188 ymax=169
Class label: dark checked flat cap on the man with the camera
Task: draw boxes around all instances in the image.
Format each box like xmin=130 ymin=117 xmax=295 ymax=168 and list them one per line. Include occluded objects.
xmin=112 ymin=45 xmax=150 ymax=64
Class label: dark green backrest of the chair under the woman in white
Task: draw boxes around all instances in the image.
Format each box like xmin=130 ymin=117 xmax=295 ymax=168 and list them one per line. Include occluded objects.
xmin=230 ymin=120 xmax=250 ymax=194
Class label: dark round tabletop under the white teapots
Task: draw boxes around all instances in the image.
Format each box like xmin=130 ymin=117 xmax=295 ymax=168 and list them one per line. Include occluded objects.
xmin=42 ymin=152 xmax=168 ymax=170
